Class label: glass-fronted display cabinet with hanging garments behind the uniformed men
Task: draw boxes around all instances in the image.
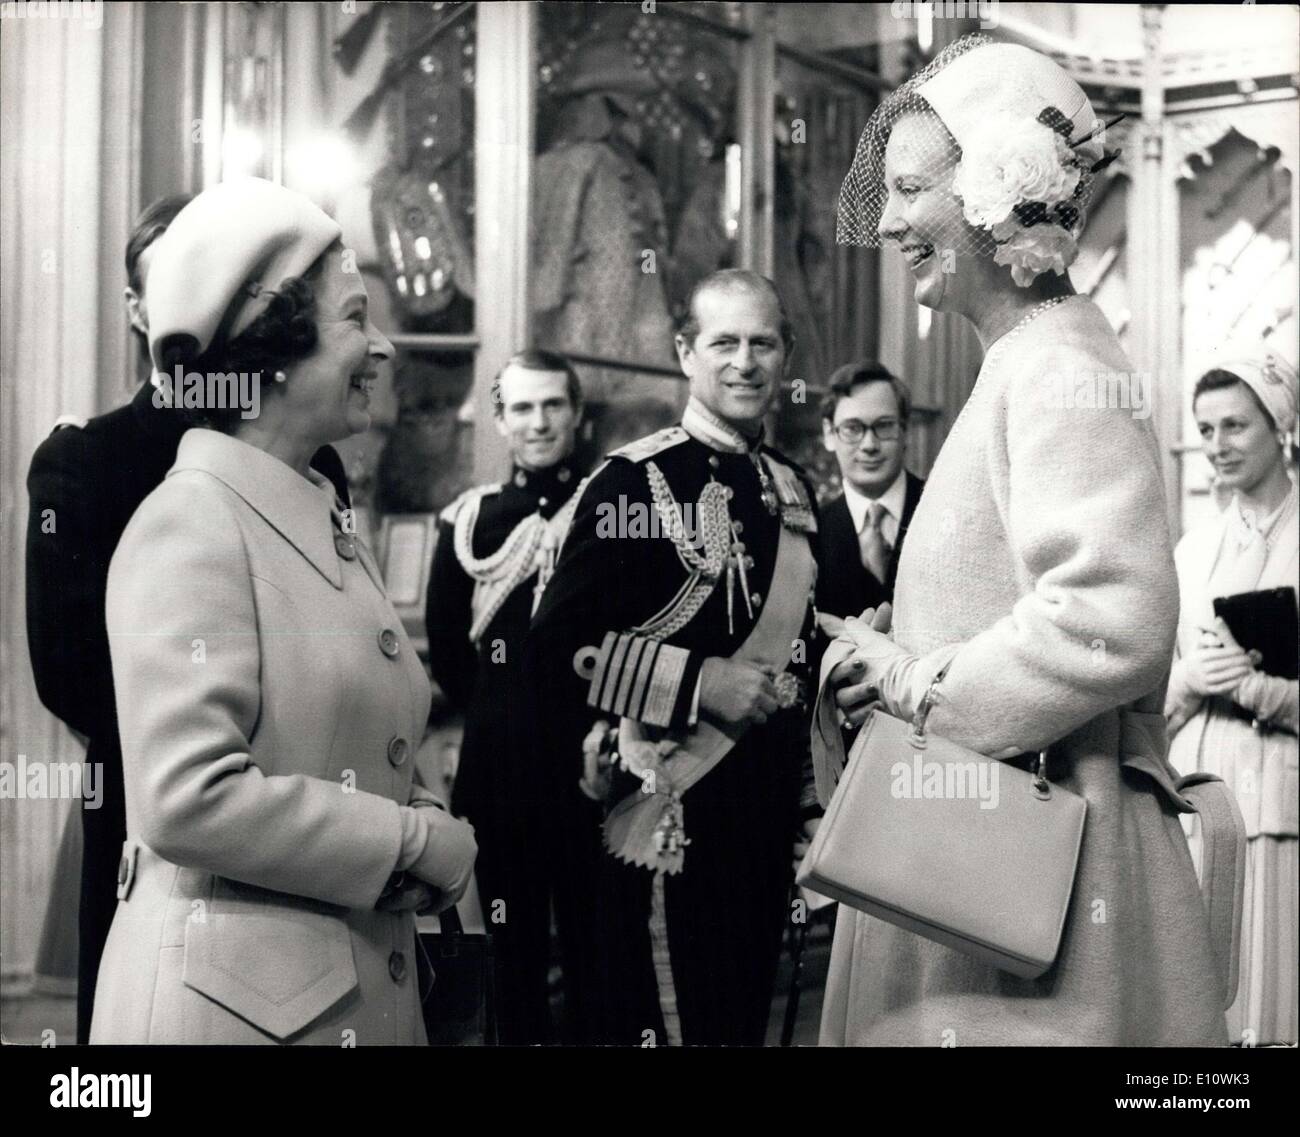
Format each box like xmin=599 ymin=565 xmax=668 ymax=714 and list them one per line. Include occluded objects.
xmin=204 ymin=3 xmax=887 ymax=554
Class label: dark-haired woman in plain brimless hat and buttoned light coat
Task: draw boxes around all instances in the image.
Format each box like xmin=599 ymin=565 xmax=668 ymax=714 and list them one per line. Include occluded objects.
xmin=91 ymin=178 xmax=476 ymax=1046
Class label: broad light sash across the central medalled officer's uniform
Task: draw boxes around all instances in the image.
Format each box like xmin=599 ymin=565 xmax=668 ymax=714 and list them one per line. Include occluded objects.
xmin=605 ymin=525 xmax=816 ymax=873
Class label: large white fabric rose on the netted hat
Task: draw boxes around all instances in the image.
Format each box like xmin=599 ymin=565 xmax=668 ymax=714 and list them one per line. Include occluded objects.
xmin=953 ymin=114 xmax=1079 ymax=229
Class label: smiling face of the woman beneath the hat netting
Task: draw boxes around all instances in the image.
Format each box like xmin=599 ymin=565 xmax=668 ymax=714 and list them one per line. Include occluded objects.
xmin=876 ymin=113 xmax=992 ymax=312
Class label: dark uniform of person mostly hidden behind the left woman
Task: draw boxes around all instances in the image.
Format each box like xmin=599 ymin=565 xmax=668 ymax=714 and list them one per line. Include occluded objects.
xmin=27 ymin=383 xmax=351 ymax=1042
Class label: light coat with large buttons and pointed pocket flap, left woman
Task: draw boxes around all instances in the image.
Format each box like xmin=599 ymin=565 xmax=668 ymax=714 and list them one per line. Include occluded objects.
xmin=91 ymin=430 xmax=429 ymax=1046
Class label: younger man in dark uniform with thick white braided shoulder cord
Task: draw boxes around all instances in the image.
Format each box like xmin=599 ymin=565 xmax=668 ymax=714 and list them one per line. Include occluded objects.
xmin=425 ymin=351 xmax=601 ymax=1045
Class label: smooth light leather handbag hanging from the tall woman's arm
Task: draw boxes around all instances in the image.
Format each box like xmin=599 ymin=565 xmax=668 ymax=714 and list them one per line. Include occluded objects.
xmin=798 ymin=668 xmax=1087 ymax=978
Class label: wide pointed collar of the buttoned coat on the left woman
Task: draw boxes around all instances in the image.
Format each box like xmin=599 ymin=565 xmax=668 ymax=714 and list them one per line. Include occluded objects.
xmin=168 ymin=428 xmax=343 ymax=589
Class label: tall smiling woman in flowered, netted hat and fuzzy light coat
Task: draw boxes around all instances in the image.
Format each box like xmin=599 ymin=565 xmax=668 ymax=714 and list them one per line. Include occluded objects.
xmin=814 ymin=36 xmax=1226 ymax=1046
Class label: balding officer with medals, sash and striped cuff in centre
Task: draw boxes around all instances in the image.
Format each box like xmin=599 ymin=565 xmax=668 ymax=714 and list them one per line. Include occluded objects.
xmin=529 ymin=269 xmax=816 ymax=1045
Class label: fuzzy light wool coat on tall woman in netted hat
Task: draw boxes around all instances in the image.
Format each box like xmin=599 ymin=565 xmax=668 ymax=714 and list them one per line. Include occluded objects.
xmin=822 ymin=296 xmax=1227 ymax=1046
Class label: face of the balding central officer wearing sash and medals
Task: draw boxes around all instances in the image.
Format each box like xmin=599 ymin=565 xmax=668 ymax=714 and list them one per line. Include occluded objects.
xmin=677 ymin=286 xmax=785 ymax=434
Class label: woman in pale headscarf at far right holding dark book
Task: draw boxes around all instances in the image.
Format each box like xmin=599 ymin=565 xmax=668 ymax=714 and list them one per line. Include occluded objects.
xmin=1165 ymin=351 xmax=1300 ymax=1045
